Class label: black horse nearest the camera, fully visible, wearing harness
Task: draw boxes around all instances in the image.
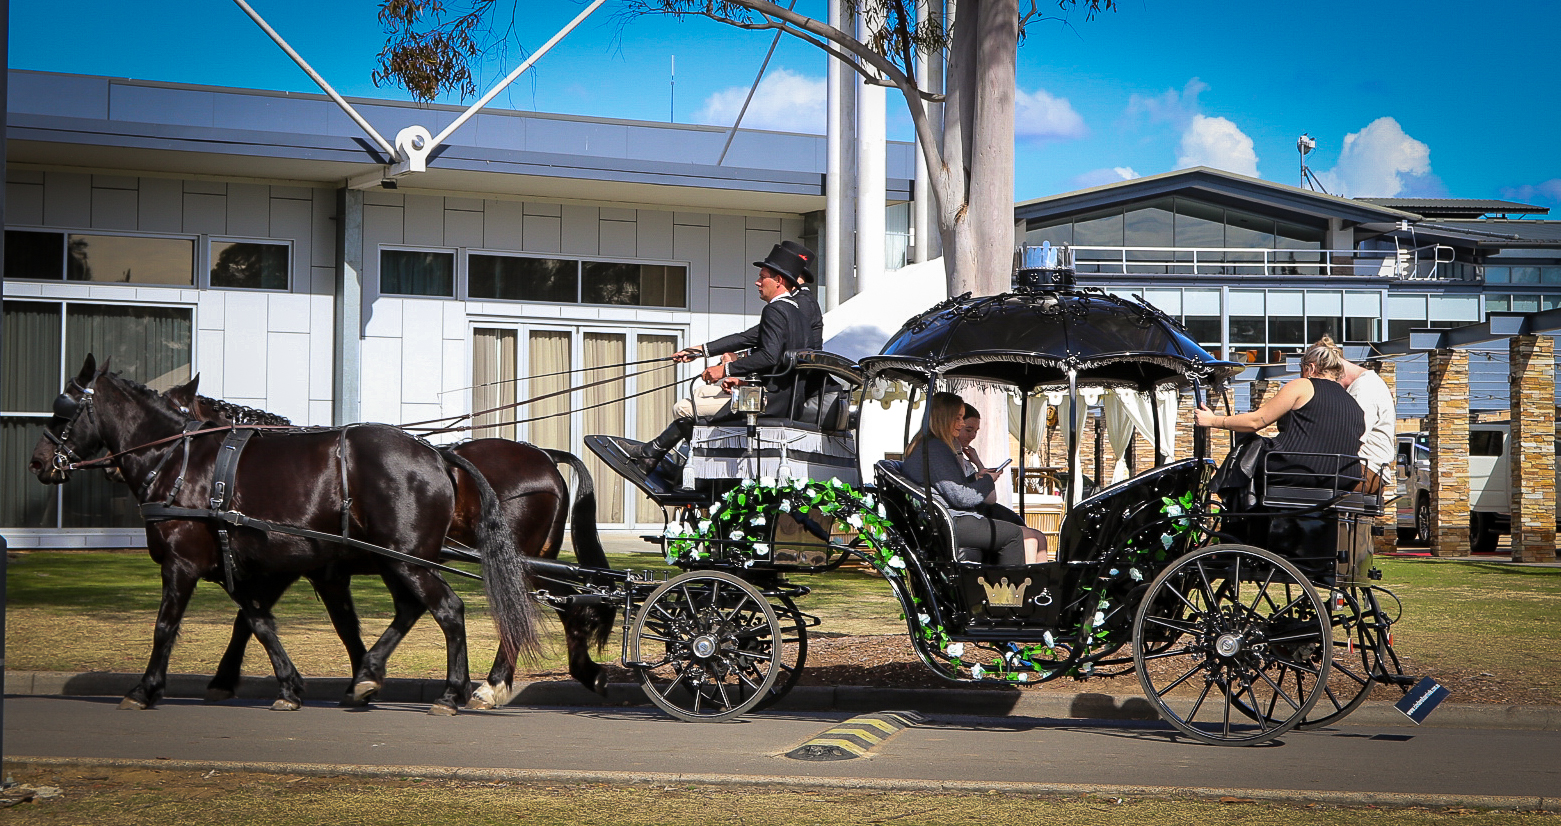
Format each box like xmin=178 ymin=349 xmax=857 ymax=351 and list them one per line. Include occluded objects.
xmin=30 ymin=356 xmax=539 ymax=714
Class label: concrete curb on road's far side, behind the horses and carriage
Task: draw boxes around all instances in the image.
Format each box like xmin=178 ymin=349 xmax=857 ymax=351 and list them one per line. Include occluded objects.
xmin=5 ymin=671 xmax=1561 ymax=731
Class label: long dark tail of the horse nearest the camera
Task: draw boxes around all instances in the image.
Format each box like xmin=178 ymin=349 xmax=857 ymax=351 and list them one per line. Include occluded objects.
xmin=439 ymin=448 xmax=542 ymax=659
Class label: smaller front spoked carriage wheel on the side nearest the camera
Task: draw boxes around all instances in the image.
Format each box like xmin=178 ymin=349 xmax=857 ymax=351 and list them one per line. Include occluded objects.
xmin=629 ymin=571 xmax=782 ymax=723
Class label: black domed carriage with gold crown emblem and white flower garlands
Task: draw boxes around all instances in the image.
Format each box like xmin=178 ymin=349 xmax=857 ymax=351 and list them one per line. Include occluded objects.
xmin=574 ymin=263 xmax=1429 ymax=745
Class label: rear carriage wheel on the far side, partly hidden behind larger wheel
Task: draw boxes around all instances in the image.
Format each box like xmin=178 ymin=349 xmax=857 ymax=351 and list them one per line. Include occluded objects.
xmin=1296 ymin=586 xmax=1403 ymax=731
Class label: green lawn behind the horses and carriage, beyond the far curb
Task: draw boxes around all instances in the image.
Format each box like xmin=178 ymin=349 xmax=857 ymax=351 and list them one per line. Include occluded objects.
xmin=6 ymin=553 xmax=1561 ymax=704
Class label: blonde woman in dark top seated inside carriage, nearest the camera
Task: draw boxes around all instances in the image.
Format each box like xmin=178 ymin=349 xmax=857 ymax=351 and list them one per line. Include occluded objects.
xmin=902 ymin=393 xmax=1046 ymax=565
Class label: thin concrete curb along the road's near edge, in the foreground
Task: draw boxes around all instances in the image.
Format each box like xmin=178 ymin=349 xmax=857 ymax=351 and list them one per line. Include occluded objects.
xmin=8 ymin=757 xmax=1561 ymax=812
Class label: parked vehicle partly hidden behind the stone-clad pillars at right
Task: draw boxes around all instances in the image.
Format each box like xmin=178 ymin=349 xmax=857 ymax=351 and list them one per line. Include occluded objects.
xmin=1397 ymin=422 xmax=1561 ymax=553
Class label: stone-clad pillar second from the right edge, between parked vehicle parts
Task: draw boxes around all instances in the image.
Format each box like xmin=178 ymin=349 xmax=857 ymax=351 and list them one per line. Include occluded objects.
xmin=1425 ymin=348 xmax=1469 ymax=556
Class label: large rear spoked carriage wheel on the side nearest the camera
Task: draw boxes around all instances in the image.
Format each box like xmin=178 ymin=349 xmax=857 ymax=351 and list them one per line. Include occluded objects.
xmin=1133 ymin=545 xmax=1332 ymax=745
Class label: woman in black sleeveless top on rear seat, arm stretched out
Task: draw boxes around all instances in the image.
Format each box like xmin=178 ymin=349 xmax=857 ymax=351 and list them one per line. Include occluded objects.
xmin=1194 ymin=342 xmax=1366 ymax=492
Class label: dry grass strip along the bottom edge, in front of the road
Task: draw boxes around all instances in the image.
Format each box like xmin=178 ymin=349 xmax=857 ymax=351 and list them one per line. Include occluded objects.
xmin=0 ymin=764 xmax=1556 ymax=826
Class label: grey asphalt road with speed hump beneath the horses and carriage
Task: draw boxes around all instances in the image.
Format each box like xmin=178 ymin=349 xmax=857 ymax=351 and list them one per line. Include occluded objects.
xmin=5 ymin=696 xmax=1561 ymax=798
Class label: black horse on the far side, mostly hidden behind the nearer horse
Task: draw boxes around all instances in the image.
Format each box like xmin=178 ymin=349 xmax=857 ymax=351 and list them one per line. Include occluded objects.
xmin=164 ymin=376 xmax=617 ymax=709
